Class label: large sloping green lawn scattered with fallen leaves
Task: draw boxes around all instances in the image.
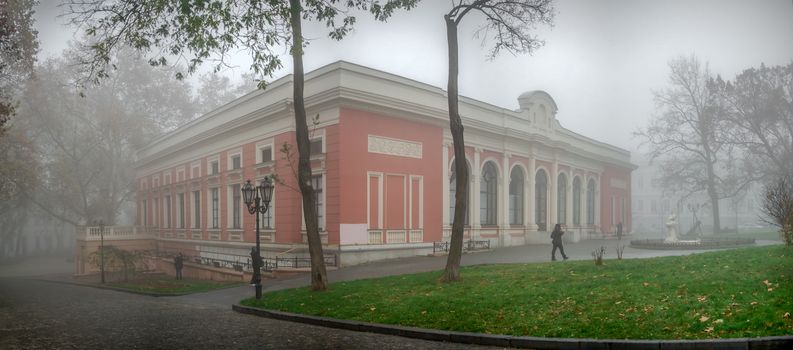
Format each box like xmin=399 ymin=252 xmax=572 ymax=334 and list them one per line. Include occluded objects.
xmin=242 ymin=246 xmax=793 ymax=339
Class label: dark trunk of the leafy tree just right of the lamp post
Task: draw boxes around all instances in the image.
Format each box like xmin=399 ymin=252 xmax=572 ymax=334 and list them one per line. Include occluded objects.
xmin=289 ymin=0 xmax=328 ymax=291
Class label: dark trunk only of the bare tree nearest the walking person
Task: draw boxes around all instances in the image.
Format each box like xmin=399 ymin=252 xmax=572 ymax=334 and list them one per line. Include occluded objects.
xmin=441 ymin=15 xmax=468 ymax=282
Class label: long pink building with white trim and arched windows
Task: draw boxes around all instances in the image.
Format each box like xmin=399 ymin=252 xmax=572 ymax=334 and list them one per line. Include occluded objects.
xmin=137 ymin=62 xmax=635 ymax=265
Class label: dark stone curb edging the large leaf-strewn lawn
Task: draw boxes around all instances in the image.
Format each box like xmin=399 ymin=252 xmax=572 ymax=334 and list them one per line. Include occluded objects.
xmin=231 ymin=304 xmax=793 ymax=350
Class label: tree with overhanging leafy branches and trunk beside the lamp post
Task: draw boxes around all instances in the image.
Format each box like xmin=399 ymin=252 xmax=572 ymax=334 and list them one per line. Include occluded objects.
xmin=67 ymin=0 xmax=417 ymax=290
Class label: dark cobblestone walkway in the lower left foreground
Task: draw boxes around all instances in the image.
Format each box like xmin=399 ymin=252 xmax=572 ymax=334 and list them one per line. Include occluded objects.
xmin=0 ymin=278 xmax=502 ymax=349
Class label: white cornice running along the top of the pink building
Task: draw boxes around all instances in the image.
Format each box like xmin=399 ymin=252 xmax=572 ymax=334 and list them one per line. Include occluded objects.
xmin=137 ymin=61 xmax=636 ymax=175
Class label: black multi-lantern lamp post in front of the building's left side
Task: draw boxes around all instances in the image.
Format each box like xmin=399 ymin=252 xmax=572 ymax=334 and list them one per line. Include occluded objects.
xmin=242 ymin=176 xmax=274 ymax=299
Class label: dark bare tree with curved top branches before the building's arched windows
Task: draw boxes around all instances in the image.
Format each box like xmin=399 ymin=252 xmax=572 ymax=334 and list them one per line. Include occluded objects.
xmin=441 ymin=0 xmax=553 ymax=282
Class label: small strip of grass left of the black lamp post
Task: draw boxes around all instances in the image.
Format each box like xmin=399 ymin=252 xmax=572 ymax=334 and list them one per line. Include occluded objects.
xmin=107 ymin=277 xmax=241 ymax=295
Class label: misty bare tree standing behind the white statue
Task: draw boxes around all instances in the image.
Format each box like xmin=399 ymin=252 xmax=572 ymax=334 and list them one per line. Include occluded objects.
xmin=636 ymin=56 xmax=752 ymax=232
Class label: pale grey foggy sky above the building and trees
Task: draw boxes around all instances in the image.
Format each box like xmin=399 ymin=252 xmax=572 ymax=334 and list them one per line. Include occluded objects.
xmin=36 ymin=0 xmax=793 ymax=152
